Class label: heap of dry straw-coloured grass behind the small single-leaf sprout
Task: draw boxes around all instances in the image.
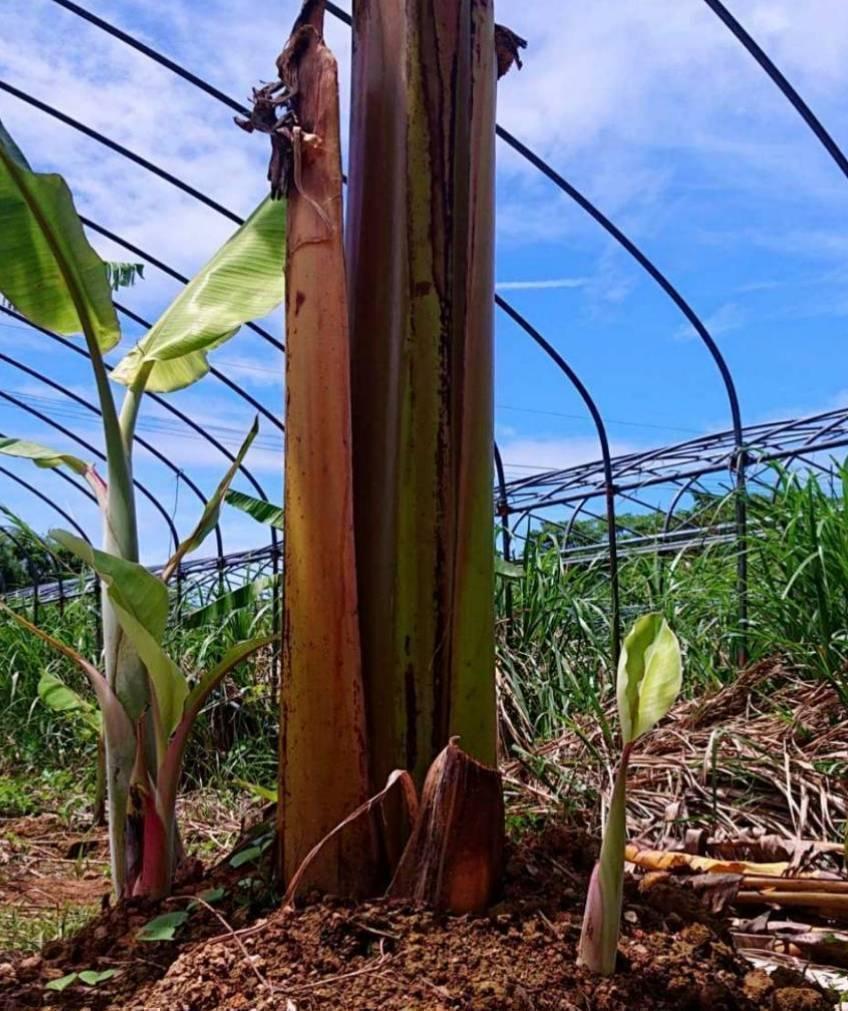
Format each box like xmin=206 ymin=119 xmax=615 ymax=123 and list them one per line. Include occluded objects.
xmin=504 ymin=658 xmax=848 ymax=845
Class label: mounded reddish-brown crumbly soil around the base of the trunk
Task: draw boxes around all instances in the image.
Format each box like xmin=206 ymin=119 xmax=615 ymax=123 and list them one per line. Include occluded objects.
xmin=0 ymin=830 xmax=833 ymax=1011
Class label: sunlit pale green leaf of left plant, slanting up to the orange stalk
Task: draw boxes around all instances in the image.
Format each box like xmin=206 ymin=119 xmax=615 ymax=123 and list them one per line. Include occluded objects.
xmin=112 ymin=197 xmax=286 ymax=392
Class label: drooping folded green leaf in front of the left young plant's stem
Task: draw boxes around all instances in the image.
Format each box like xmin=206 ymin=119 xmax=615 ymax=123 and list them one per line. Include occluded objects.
xmin=50 ymin=530 xmax=188 ymax=741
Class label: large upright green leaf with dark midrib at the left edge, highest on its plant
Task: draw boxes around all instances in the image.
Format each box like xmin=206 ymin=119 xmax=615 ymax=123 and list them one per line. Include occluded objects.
xmin=0 ymin=122 xmax=120 ymax=351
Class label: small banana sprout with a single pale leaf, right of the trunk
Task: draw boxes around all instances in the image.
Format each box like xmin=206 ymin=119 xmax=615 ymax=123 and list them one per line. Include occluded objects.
xmin=577 ymin=614 xmax=682 ymax=976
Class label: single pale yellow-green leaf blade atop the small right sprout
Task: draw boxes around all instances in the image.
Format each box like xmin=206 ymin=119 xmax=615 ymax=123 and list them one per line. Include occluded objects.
xmin=618 ymin=614 xmax=682 ymax=744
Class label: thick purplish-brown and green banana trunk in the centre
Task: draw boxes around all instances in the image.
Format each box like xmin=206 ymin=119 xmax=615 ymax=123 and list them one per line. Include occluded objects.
xmin=347 ymin=0 xmax=496 ymax=789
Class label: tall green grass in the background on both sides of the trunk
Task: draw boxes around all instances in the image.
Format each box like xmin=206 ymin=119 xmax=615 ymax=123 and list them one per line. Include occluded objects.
xmin=0 ymin=466 xmax=848 ymax=786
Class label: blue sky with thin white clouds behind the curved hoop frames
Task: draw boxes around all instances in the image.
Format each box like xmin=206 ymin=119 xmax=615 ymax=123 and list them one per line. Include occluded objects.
xmin=0 ymin=0 xmax=848 ymax=561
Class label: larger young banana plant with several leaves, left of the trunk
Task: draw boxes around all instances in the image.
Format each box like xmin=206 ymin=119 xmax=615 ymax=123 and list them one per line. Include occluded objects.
xmin=0 ymin=122 xmax=286 ymax=897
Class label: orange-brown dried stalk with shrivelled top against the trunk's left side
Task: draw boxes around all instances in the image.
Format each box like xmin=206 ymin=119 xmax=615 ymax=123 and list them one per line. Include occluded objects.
xmin=278 ymin=3 xmax=374 ymax=895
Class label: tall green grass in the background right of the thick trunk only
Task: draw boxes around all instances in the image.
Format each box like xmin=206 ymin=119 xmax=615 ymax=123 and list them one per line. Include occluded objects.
xmin=497 ymin=466 xmax=848 ymax=747
